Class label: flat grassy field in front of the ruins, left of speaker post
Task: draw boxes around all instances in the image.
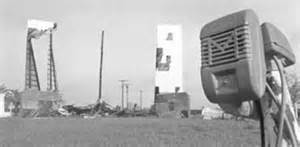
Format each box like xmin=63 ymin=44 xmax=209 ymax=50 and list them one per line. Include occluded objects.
xmin=0 ymin=118 xmax=260 ymax=147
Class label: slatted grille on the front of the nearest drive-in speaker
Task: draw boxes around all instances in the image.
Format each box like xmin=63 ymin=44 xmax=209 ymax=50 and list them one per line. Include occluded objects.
xmin=201 ymin=25 xmax=251 ymax=67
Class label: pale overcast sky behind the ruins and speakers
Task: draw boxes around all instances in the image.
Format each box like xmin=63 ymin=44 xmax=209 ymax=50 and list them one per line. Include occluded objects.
xmin=0 ymin=0 xmax=300 ymax=108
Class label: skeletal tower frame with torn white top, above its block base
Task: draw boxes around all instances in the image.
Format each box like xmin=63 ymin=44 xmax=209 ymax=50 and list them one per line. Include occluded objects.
xmin=25 ymin=20 xmax=58 ymax=91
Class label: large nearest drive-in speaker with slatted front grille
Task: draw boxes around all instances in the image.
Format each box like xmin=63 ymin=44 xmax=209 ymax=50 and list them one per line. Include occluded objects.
xmin=200 ymin=10 xmax=266 ymax=103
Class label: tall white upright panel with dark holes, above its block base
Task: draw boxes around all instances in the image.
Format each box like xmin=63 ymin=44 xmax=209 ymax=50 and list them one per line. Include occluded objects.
xmin=155 ymin=25 xmax=183 ymax=93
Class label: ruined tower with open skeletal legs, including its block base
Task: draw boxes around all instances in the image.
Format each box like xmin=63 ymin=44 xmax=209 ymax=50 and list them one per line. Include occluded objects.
xmin=20 ymin=20 xmax=62 ymax=117
